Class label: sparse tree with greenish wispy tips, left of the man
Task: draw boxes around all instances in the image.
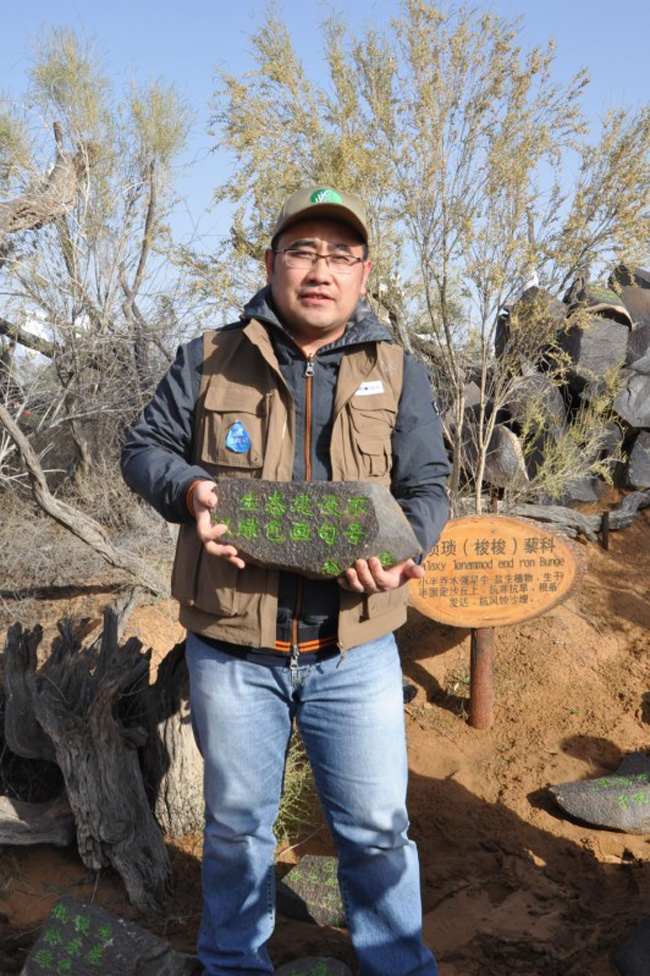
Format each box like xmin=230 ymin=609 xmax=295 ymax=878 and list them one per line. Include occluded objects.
xmin=0 ymin=30 xmax=189 ymax=488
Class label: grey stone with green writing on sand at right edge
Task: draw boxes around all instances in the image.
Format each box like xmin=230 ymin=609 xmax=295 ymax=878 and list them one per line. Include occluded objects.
xmin=550 ymin=752 xmax=650 ymax=834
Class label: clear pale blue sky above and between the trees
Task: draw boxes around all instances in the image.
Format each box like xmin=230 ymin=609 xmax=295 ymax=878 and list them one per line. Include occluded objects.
xmin=0 ymin=0 xmax=650 ymax=243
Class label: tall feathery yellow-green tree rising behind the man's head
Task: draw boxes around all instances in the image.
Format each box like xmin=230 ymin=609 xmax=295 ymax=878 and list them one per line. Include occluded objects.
xmin=200 ymin=0 xmax=650 ymax=509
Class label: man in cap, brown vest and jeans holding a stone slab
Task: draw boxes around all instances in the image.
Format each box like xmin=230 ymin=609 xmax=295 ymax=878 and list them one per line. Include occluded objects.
xmin=123 ymin=187 xmax=448 ymax=976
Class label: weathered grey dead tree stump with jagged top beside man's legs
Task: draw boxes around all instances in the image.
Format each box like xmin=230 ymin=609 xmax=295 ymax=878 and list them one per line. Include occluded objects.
xmin=5 ymin=610 xmax=202 ymax=913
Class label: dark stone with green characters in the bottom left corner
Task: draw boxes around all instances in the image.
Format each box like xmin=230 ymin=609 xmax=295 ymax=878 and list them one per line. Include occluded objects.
xmin=22 ymin=896 xmax=202 ymax=976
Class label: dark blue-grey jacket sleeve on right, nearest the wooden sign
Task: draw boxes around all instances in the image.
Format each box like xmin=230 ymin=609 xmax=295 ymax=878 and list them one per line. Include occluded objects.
xmin=391 ymin=353 xmax=450 ymax=555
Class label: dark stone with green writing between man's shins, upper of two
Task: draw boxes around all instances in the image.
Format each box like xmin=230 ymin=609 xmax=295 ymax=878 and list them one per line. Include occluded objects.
xmin=276 ymin=854 xmax=346 ymax=926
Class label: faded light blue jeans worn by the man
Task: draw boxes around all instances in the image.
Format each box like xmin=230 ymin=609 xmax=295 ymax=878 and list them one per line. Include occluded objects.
xmin=187 ymin=634 xmax=438 ymax=976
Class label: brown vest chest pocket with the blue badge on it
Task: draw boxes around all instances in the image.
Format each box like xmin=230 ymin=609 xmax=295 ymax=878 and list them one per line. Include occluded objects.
xmin=200 ymin=386 xmax=268 ymax=478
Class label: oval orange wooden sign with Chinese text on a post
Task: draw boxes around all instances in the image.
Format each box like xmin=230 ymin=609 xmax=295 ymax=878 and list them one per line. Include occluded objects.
xmin=409 ymin=515 xmax=586 ymax=627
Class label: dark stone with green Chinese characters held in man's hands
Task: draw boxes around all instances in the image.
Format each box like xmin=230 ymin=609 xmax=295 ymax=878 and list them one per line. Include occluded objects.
xmin=212 ymin=478 xmax=421 ymax=579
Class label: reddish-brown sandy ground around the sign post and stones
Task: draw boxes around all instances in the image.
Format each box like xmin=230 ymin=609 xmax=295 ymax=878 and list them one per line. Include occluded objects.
xmin=0 ymin=511 xmax=650 ymax=976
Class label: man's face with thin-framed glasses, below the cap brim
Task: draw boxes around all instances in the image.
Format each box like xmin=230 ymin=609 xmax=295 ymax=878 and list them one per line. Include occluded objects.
xmin=265 ymin=219 xmax=370 ymax=352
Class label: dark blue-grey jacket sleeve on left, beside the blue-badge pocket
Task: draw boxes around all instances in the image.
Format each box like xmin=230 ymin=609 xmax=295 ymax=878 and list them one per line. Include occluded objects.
xmin=121 ymin=338 xmax=214 ymax=522
